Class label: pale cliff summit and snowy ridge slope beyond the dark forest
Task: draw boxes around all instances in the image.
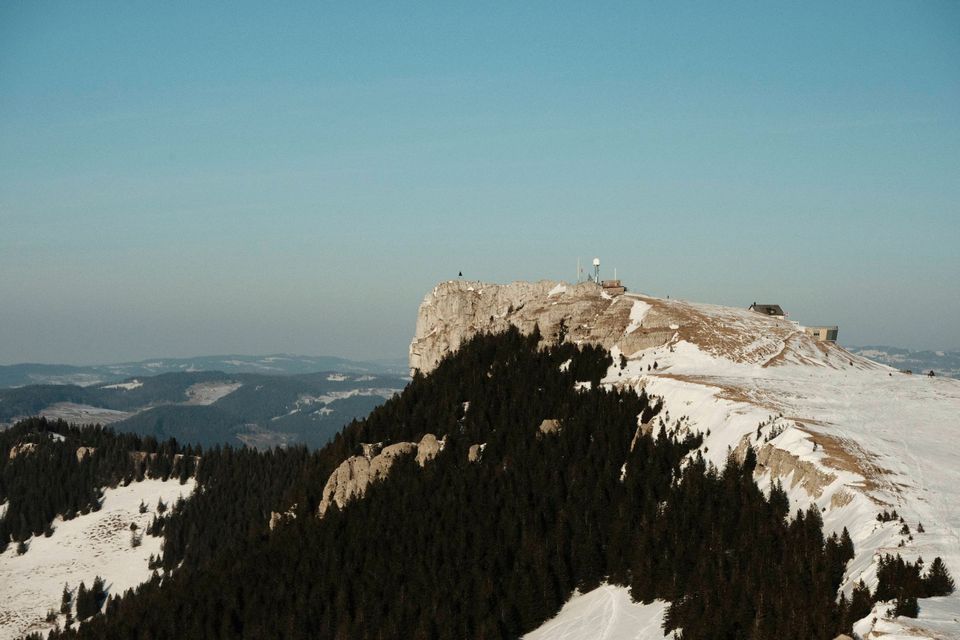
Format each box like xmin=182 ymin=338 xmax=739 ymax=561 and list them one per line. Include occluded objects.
xmin=411 ymin=282 xmax=960 ymax=638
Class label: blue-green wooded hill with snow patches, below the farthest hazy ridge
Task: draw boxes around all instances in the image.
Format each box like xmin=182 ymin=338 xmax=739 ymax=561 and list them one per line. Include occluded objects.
xmin=0 ymin=365 xmax=407 ymax=448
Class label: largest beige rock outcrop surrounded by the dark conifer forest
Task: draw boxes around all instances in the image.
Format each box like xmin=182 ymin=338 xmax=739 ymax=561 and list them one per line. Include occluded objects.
xmin=318 ymin=433 xmax=444 ymax=517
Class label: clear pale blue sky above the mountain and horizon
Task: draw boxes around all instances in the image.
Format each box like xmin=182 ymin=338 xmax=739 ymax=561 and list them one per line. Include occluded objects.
xmin=0 ymin=0 xmax=960 ymax=364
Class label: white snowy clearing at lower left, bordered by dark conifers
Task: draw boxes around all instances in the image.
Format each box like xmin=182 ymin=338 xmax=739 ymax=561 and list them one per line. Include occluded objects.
xmin=0 ymin=479 xmax=195 ymax=640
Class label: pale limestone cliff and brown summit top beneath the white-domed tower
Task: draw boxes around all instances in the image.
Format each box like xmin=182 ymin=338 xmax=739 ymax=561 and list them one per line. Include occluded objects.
xmin=409 ymin=280 xmax=878 ymax=373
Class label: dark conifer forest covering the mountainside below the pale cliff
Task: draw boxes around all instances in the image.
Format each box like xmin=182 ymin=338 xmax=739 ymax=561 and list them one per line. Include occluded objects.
xmin=3 ymin=330 xmax=953 ymax=640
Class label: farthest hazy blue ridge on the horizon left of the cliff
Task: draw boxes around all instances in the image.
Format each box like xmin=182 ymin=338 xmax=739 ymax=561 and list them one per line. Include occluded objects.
xmin=0 ymin=354 xmax=407 ymax=389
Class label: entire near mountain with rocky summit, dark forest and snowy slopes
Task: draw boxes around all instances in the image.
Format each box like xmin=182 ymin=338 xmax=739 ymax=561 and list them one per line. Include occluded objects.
xmin=0 ymin=282 xmax=960 ymax=640
